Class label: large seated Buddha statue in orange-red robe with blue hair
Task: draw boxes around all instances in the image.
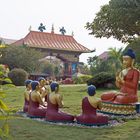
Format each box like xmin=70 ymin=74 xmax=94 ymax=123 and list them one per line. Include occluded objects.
xmin=101 ymin=49 xmax=140 ymax=104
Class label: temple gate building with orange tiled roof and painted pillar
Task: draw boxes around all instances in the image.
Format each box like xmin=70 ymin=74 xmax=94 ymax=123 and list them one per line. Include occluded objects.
xmin=12 ymin=31 xmax=91 ymax=77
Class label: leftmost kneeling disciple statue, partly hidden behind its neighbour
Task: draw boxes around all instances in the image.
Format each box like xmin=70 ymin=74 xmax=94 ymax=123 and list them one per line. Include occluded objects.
xmin=23 ymin=79 xmax=32 ymax=113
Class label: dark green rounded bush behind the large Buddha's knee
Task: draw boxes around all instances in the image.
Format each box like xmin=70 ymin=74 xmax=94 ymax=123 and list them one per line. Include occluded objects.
xmin=87 ymin=72 xmax=115 ymax=88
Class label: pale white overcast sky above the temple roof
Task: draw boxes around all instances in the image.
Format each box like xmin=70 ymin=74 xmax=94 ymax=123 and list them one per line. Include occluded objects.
xmin=0 ymin=0 xmax=126 ymax=63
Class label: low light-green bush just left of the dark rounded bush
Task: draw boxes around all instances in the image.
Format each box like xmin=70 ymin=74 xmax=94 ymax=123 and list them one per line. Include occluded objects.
xmin=72 ymin=75 xmax=92 ymax=84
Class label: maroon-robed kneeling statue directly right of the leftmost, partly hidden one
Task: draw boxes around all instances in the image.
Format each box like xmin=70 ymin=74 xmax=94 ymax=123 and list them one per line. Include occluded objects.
xmin=28 ymin=81 xmax=47 ymax=118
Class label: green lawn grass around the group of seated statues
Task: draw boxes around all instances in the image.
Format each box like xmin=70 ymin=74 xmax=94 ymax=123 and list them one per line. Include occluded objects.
xmin=0 ymin=85 xmax=140 ymax=140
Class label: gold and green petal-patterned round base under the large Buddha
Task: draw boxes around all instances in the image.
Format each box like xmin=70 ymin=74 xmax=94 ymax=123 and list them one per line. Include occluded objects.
xmin=98 ymin=102 xmax=140 ymax=115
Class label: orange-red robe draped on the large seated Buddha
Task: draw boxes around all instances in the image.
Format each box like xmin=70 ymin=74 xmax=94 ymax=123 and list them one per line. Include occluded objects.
xmin=101 ymin=69 xmax=140 ymax=104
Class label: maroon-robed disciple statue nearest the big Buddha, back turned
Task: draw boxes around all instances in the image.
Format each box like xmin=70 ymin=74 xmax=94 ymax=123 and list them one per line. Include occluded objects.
xmin=76 ymin=85 xmax=108 ymax=125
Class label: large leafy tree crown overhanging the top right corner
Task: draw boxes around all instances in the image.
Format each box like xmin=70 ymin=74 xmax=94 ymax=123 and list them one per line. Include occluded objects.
xmin=85 ymin=0 xmax=140 ymax=42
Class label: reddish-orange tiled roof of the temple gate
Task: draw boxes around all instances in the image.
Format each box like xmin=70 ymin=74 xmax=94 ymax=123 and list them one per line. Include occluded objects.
xmin=12 ymin=31 xmax=90 ymax=53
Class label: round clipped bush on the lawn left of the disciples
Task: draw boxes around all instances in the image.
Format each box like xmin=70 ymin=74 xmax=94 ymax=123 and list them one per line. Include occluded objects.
xmin=8 ymin=68 xmax=28 ymax=86
